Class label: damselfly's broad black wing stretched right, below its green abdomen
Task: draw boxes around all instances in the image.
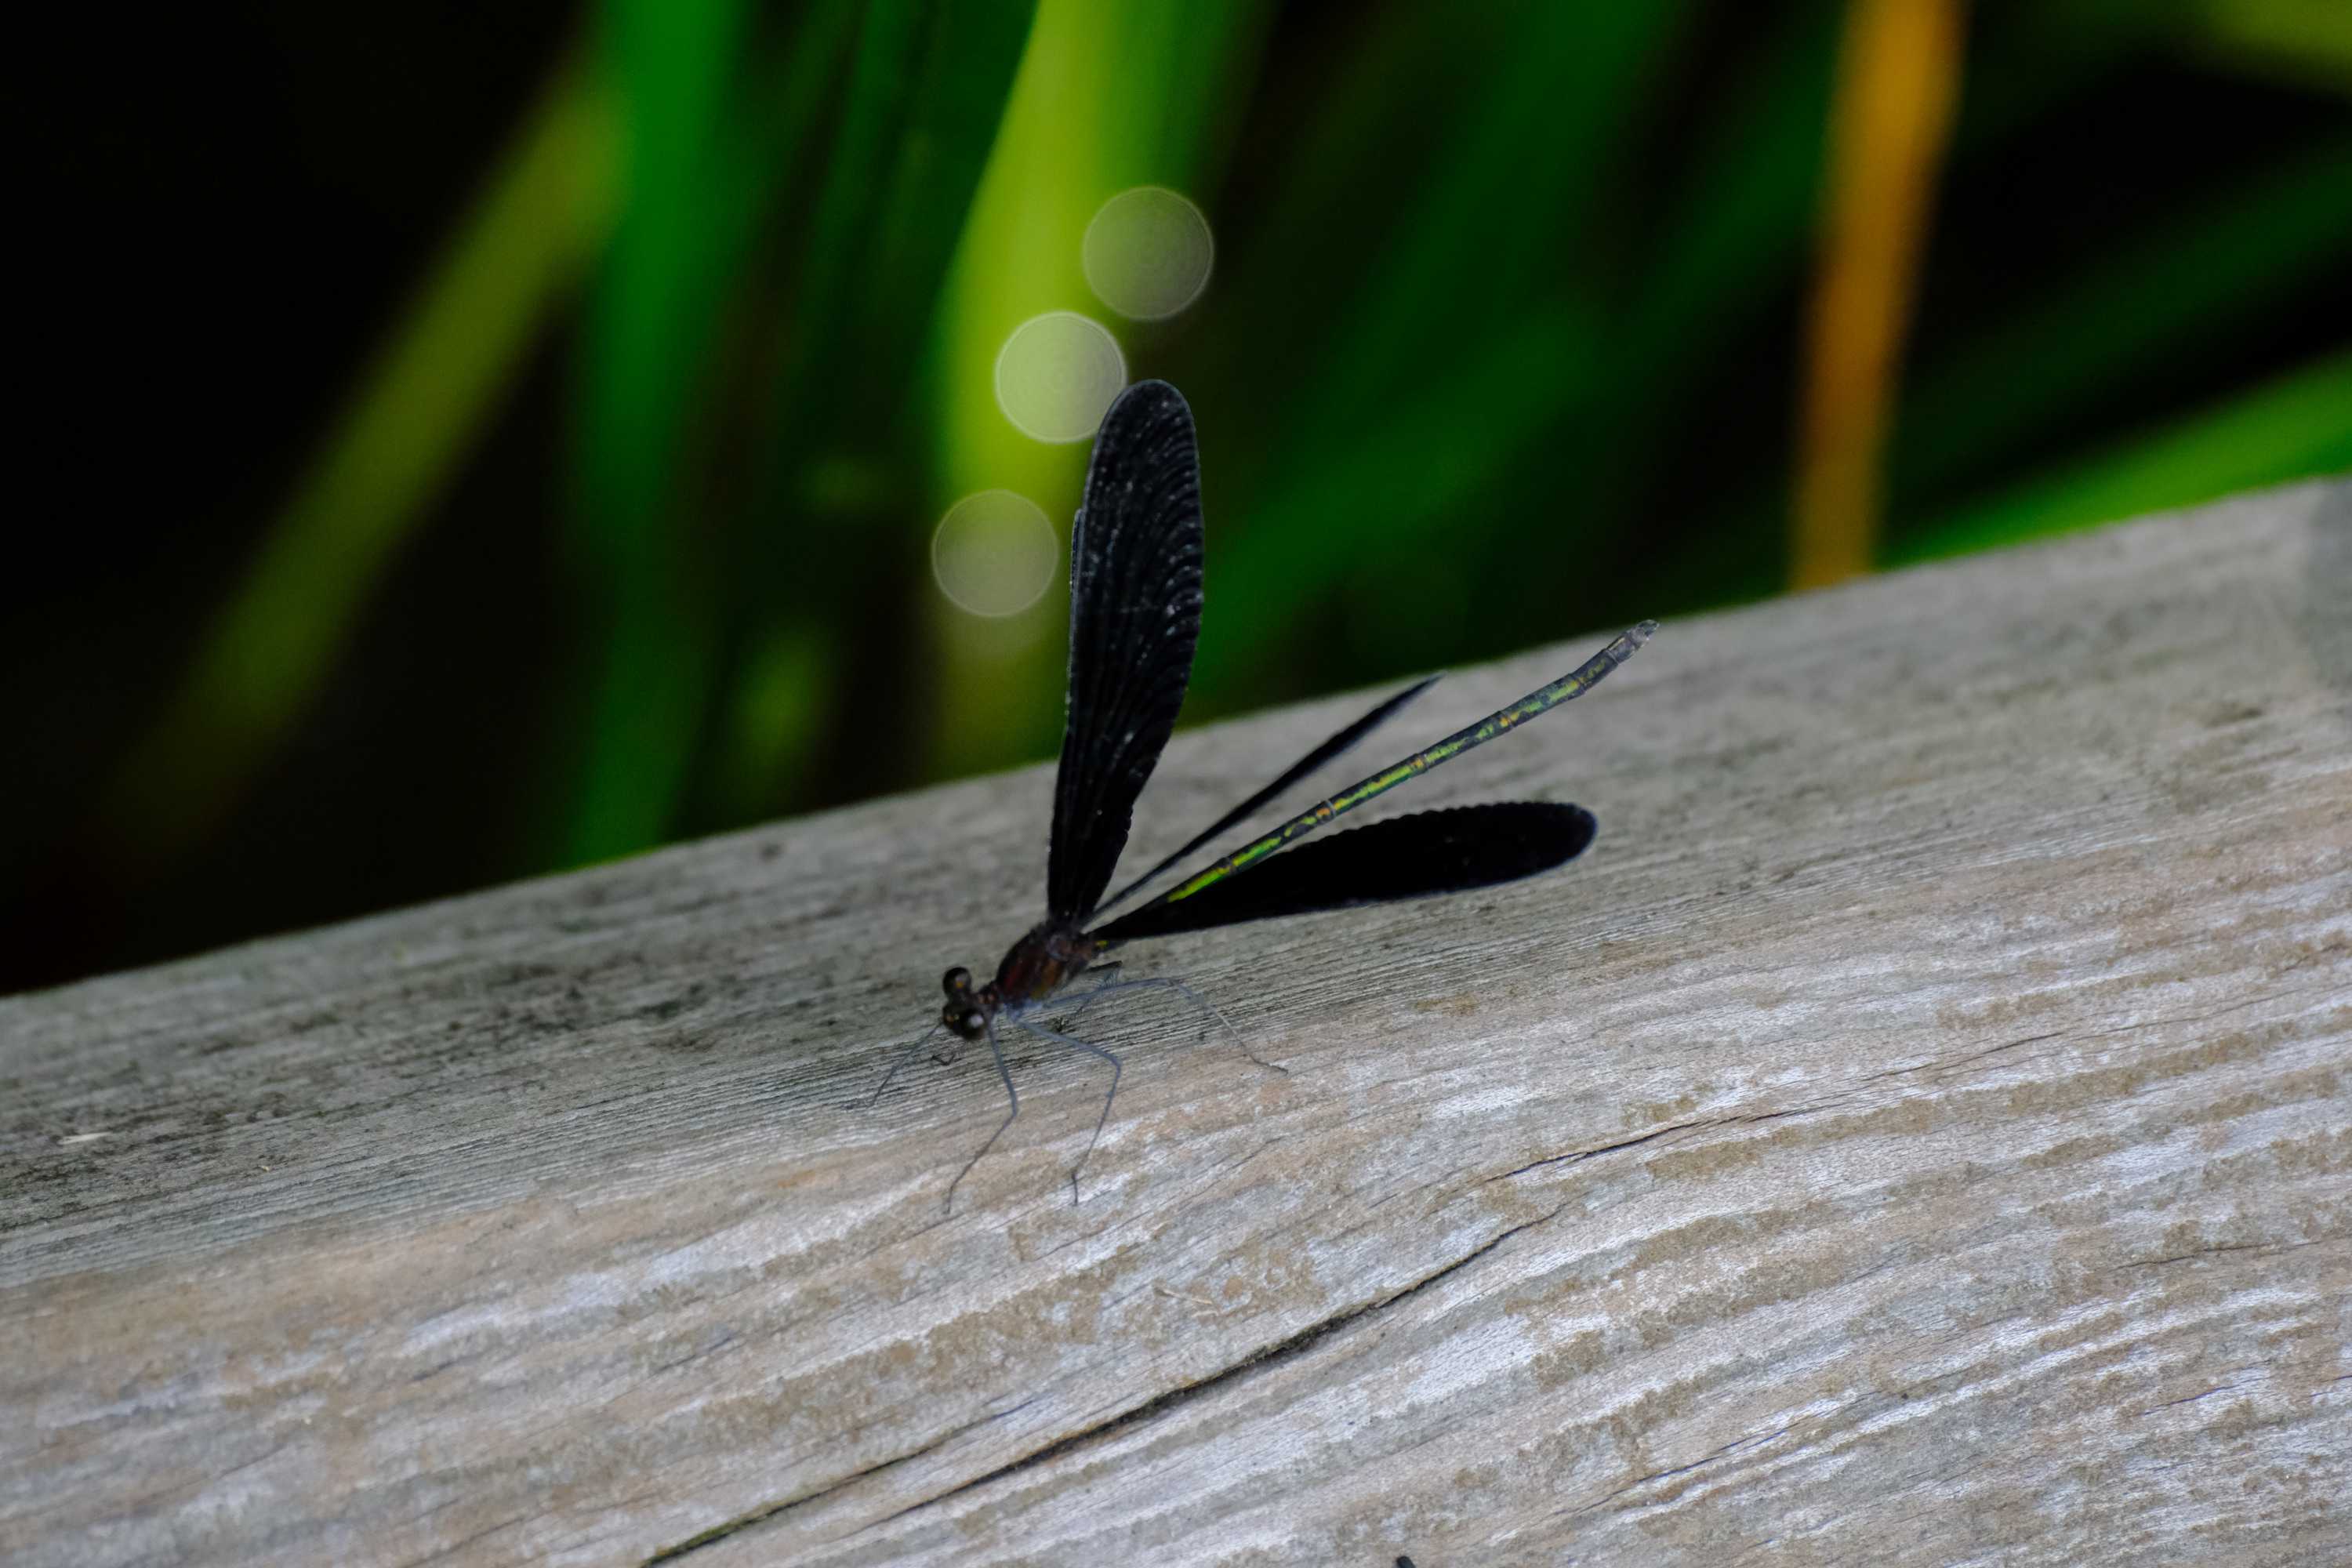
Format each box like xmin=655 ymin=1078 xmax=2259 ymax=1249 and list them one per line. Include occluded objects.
xmin=1094 ymin=801 xmax=1595 ymax=945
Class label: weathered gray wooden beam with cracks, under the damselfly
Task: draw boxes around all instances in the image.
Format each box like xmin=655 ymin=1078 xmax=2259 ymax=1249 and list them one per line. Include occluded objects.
xmin=0 ymin=482 xmax=2352 ymax=1568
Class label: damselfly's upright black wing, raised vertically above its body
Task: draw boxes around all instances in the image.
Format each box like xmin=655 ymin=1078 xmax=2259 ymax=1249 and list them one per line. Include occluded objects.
xmin=1047 ymin=381 xmax=1202 ymax=921
